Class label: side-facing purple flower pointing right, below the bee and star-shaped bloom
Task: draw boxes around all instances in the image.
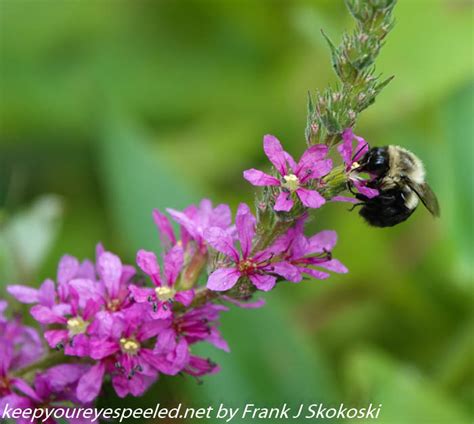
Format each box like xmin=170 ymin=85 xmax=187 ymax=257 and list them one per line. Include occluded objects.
xmin=271 ymin=217 xmax=348 ymax=283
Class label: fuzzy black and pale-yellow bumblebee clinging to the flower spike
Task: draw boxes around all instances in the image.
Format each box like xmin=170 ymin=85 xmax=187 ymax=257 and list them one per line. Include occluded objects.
xmin=352 ymin=146 xmax=440 ymax=227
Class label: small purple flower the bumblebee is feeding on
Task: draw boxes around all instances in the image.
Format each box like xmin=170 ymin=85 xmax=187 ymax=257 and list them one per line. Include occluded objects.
xmin=332 ymin=128 xmax=379 ymax=202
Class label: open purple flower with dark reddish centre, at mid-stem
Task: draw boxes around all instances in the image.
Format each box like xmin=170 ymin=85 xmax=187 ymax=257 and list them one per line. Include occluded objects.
xmin=204 ymin=203 xmax=297 ymax=291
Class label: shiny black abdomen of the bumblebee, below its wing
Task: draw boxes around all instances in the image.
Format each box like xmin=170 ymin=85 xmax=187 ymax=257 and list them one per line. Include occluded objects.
xmin=358 ymin=189 xmax=415 ymax=227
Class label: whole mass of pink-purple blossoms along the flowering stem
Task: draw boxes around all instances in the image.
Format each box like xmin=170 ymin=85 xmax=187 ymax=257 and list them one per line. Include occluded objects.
xmin=0 ymin=133 xmax=364 ymax=407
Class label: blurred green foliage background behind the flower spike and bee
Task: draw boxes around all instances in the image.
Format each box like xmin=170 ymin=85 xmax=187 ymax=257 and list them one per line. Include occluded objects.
xmin=0 ymin=0 xmax=474 ymax=424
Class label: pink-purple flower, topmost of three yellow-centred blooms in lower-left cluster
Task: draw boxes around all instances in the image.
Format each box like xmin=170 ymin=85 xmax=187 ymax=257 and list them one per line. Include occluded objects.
xmin=129 ymin=243 xmax=194 ymax=319
